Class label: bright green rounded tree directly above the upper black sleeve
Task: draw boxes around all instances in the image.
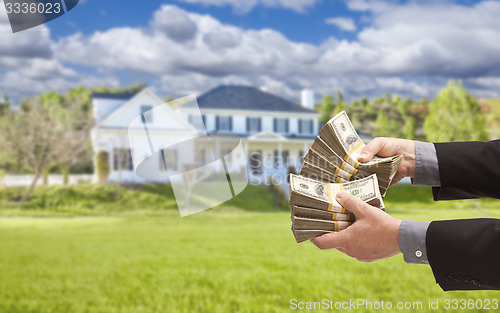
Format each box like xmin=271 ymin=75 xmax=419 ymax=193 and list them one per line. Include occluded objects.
xmin=424 ymin=81 xmax=488 ymax=142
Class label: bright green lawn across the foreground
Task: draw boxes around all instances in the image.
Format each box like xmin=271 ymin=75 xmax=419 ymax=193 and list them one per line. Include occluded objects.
xmin=0 ymin=204 xmax=500 ymax=313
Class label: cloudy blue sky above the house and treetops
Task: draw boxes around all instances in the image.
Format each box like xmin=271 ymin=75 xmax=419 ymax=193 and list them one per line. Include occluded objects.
xmin=0 ymin=0 xmax=500 ymax=102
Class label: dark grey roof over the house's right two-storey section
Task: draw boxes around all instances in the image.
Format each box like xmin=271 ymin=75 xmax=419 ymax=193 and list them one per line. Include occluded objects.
xmin=198 ymin=86 xmax=317 ymax=113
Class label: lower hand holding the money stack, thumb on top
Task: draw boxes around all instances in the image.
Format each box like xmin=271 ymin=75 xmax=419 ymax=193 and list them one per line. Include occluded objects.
xmin=311 ymin=192 xmax=401 ymax=262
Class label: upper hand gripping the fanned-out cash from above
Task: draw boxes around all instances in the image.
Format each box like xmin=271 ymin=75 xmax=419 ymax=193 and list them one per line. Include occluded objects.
xmin=358 ymin=137 xmax=415 ymax=186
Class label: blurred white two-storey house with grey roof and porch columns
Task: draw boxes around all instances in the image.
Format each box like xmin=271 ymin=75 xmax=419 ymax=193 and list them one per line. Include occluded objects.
xmin=91 ymin=86 xmax=319 ymax=182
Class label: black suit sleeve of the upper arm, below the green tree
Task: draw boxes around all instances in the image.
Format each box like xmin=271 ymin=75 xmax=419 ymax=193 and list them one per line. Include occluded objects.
xmin=432 ymin=140 xmax=500 ymax=200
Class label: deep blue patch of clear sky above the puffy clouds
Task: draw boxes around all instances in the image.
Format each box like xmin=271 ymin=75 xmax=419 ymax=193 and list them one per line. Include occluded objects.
xmin=48 ymin=0 xmax=367 ymax=44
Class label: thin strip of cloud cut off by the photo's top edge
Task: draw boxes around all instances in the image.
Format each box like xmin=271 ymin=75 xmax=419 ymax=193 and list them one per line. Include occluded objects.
xmin=177 ymin=0 xmax=318 ymax=14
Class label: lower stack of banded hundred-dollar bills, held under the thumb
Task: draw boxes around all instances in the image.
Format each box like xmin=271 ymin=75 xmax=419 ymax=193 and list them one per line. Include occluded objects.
xmin=289 ymin=174 xmax=384 ymax=242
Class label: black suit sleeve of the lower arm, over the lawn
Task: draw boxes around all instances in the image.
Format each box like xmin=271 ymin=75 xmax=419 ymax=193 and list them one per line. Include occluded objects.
xmin=426 ymin=219 xmax=500 ymax=291
